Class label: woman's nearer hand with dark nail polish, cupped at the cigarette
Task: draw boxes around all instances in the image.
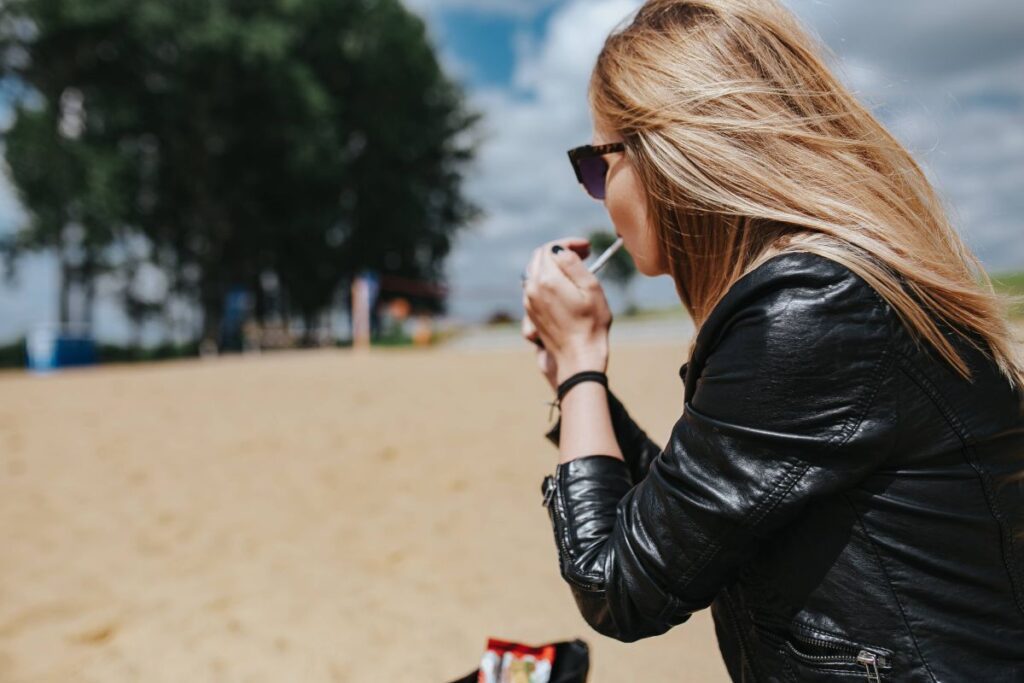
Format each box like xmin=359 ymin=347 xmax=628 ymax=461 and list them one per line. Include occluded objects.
xmin=523 ymin=238 xmax=611 ymax=386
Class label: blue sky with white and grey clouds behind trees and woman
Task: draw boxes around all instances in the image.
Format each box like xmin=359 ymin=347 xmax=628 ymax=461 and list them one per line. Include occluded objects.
xmin=0 ymin=0 xmax=1024 ymax=340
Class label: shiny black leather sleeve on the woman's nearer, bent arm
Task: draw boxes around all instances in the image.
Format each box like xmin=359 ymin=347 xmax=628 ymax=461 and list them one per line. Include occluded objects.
xmin=542 ymin=262 xmax=896 ymax=642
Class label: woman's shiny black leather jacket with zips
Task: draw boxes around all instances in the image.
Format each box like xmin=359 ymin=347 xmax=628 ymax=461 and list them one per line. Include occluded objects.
xmin=542 ymin=253 xmax=1024 ymax=683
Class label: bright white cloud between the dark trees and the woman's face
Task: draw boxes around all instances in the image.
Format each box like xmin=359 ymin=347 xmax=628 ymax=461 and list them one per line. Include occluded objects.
xmin=449 ymin=0 xmax=674 ymax=317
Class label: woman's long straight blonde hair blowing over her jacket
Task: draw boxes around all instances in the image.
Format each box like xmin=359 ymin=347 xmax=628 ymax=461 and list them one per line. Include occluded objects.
xmin=590 ymin=0 xmax=1024 ymax=388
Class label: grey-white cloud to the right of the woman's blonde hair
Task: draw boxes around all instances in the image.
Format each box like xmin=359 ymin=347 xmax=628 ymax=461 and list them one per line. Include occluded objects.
xmin=793 ymin=0 xmax=1024 ymax=270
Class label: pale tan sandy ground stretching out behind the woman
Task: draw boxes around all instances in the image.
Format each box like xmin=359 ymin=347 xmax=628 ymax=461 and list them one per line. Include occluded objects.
xmin=0 ymin=342 xmax=728 ymax=683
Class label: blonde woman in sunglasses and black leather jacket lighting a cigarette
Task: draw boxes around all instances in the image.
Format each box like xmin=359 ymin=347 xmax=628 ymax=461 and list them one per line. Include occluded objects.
xmin=523 ymin=0 xmax=1024 ymax=681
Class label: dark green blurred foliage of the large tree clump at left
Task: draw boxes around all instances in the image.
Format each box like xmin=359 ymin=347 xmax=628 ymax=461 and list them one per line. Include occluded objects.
xmin=0 ymin=0 xmax=475 ymax=337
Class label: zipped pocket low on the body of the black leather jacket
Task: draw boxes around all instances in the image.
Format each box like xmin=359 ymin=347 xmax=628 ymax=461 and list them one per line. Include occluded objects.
xmin=781 ymin=632 xmax=892 ymax=683
